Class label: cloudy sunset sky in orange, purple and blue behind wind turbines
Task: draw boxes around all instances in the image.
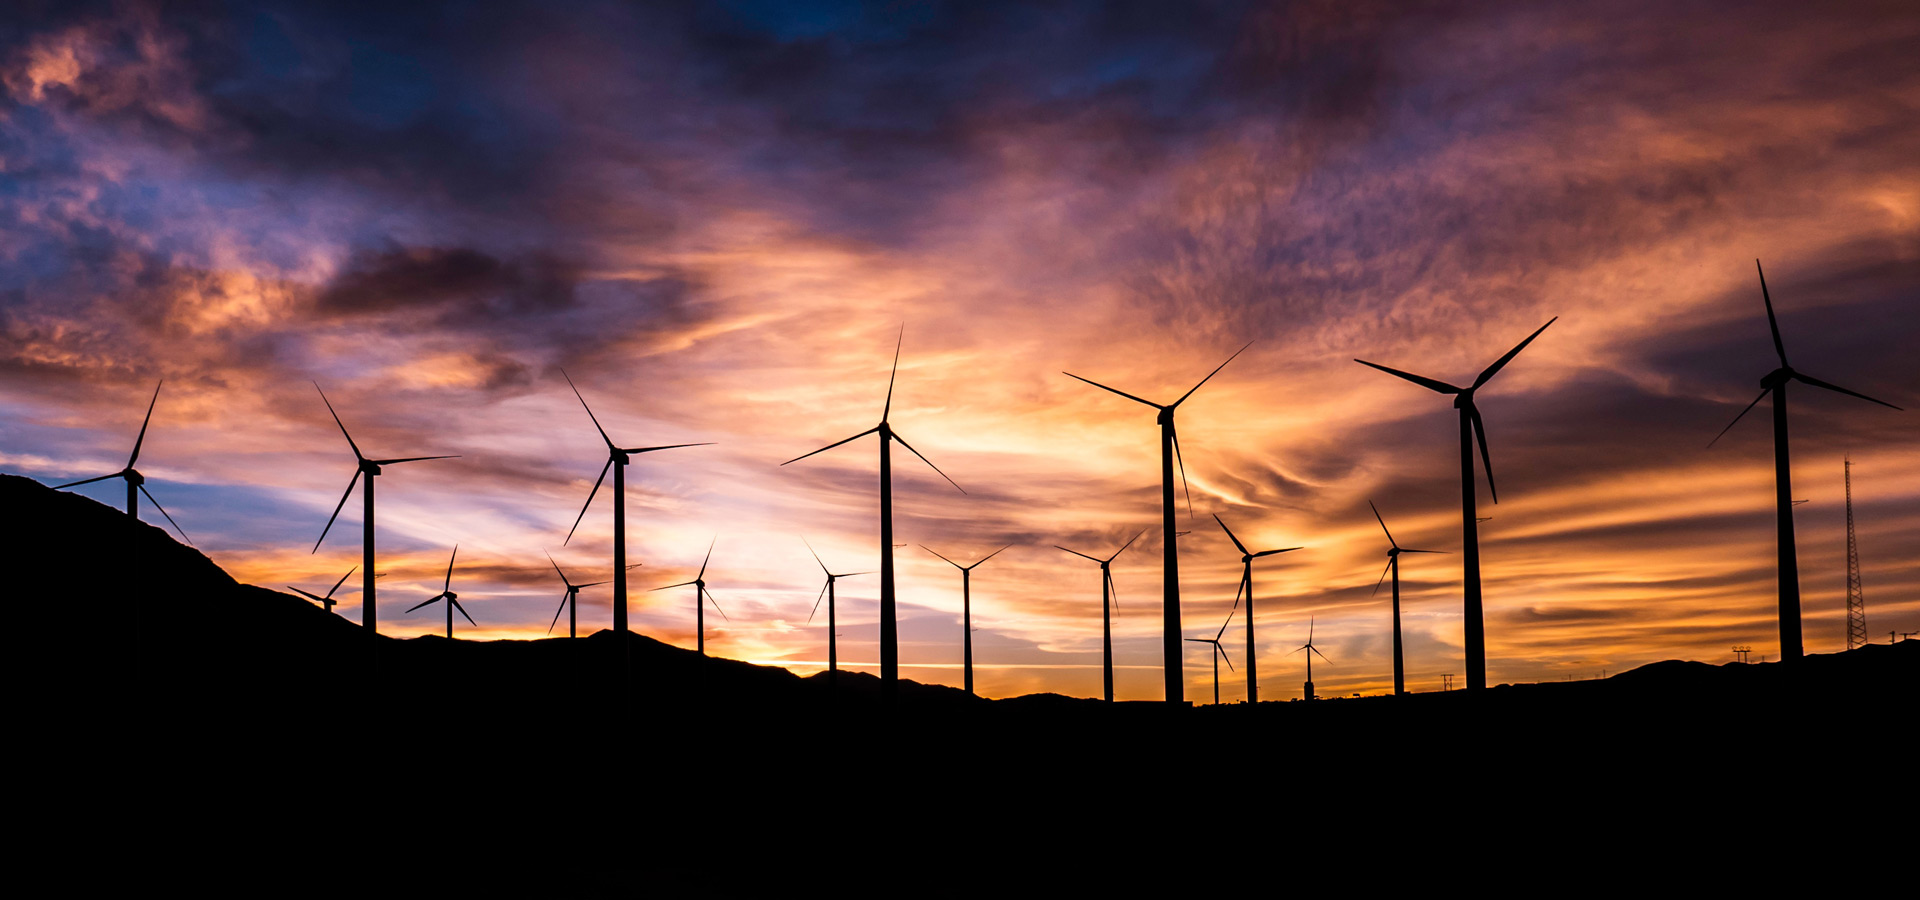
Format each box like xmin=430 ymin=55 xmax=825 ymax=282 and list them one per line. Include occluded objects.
xmin=0 ymin=0 xmax=1920 ymax=699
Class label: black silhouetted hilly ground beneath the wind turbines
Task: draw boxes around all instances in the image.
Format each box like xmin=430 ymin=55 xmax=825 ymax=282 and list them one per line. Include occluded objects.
xmin=15 ymin=476 xmax=1920 ymax=896
